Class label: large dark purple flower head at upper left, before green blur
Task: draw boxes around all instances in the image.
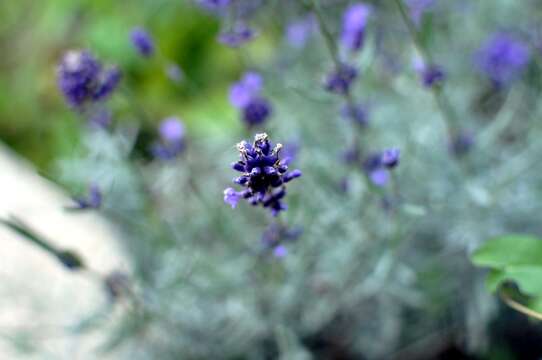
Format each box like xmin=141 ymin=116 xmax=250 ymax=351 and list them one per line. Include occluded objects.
xmin=57 ymin=50 xmax=102 ymax=107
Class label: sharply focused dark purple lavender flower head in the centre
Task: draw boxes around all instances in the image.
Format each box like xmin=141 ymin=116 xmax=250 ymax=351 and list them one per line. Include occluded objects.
xmin=224 ymin=134 xmax=301 ymax=216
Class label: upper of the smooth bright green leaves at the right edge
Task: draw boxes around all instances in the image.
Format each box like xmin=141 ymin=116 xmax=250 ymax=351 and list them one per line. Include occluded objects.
xmin=471 ymin=235 xmax=542 ymax=268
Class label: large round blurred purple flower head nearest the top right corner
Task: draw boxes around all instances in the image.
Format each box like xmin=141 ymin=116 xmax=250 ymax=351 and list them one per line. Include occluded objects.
xmin=476 ymin=33 xmax=530 ymax=86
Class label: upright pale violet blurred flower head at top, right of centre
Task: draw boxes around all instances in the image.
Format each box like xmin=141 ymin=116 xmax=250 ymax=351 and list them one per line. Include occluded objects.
xmin=341 ymin=3 xmax=371 ymax=51
